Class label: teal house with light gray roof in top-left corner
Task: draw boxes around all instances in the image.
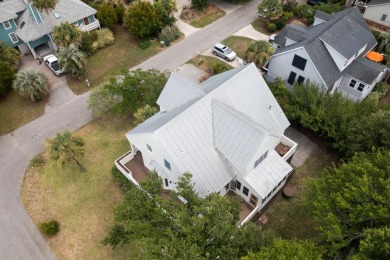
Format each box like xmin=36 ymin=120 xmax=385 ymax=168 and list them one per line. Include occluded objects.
xmin=0 ymin=0 xmax=100 ymax=58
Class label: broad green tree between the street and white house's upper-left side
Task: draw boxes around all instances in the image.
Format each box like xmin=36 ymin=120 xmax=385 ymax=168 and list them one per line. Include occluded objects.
xmin=88 ymin=69 xmax=167 ymax=116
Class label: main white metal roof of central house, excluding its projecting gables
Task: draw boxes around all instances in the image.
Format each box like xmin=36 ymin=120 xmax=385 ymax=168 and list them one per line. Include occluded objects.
xmin=126 ymin=64 xmax=289 ymax=196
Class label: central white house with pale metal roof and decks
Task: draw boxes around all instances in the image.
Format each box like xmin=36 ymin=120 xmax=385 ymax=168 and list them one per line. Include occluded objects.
xmin=116 ymin=64 xmax=297 ymax=223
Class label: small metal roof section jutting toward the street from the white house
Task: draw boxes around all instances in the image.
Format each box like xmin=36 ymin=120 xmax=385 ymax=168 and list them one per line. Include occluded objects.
xmin=156 ymin=73 xmax=206 ymax=111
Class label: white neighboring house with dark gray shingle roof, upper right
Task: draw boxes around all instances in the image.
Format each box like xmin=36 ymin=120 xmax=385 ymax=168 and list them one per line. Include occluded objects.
xmin=267 ymin=7 xmax=387 ymax=101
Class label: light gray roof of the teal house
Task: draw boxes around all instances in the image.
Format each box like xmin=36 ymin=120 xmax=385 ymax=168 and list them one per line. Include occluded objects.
xmin=15 ymin=0 xmax=96 ymax=42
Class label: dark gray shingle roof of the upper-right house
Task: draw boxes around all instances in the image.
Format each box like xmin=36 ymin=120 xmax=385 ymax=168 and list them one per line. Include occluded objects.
xmin=271 ymin=7 xmax=377 ymax=88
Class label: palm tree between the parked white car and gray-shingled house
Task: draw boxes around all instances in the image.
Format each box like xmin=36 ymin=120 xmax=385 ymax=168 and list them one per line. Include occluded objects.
xmin=245 ymin=41 xmax=274 ymax=67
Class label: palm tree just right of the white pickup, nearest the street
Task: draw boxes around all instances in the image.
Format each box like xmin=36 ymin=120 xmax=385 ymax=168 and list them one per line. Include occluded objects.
xmin=58 ymin=44 xmax=87 ymax=79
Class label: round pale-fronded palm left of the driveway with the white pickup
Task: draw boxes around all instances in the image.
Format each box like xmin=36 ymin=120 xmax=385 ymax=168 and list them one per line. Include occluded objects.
xmin=13 ymin=70 xmax=49 ymax=102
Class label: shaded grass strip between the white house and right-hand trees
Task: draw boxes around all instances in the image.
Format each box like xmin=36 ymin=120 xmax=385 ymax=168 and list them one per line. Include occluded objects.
xmin=264 ymin=136 xmax=338 ymax=239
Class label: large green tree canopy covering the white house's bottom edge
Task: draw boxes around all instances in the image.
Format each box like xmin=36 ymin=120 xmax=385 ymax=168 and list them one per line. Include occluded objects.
xmin=103 ymin=173 xmax=273 ymax=259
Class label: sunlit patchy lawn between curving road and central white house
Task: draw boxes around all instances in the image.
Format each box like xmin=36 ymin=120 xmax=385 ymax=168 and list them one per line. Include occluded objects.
xmin=22 ymin=118 xmax=133 ymax=259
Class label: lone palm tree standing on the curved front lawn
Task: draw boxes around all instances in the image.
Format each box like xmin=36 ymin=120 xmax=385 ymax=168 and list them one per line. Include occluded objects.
xmin=49 ymin=131 xmax=86 ymax=172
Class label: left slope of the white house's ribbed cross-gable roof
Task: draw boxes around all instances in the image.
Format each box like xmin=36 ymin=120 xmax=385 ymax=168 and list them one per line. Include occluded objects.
xmin=212 ymin=100 xmax=274 ymax=173
